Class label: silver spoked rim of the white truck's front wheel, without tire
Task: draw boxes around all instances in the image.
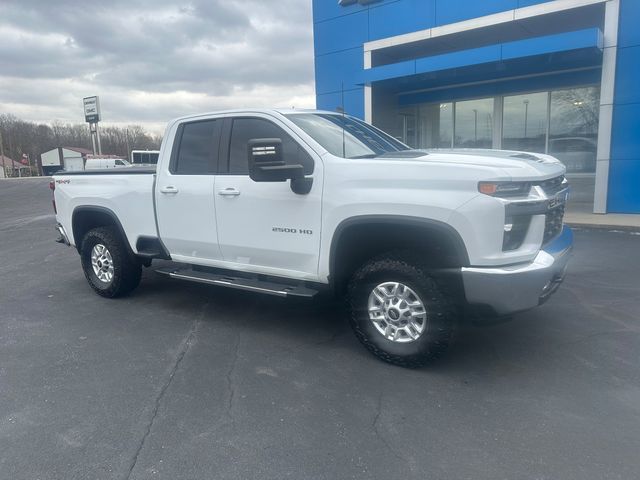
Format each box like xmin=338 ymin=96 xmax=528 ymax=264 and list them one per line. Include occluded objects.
xmin=368 ymin=282 xmax=427 ymax=343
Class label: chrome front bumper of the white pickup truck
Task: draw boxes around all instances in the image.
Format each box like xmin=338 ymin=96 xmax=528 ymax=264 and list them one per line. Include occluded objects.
xmin=462 ymin=226 xmax=573 ymax=316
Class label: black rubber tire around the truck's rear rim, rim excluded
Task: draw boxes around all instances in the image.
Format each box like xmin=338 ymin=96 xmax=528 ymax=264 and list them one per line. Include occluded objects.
xmin=80 ymin=227 xmax=142 ymax=298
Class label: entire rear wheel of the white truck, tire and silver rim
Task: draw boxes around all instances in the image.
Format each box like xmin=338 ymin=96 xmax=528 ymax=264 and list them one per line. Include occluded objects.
xmin=80 ymin=227 xmax=142 ymax=298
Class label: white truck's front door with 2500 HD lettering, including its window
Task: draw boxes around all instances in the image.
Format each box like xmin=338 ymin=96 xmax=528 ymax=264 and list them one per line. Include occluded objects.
xmin=215 ymin=116 xmax=323 ymax=280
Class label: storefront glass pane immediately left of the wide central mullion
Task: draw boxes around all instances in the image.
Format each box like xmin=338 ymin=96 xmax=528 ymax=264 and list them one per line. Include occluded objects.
xmin=453 ymin=98 xmax=493 ymax=148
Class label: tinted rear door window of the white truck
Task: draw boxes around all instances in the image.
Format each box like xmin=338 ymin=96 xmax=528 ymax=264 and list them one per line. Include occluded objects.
xmin=172 ymin=120 xmax=218 ymax=175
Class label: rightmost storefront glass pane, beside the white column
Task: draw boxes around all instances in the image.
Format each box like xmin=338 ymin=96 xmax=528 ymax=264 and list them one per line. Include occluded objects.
xmin=549 ymin=87 xmax=600 ymax=173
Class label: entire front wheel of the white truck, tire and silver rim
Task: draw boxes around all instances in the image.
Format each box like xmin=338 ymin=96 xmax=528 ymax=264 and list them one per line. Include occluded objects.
xmin=348 ymin=254 xmax=457 ymax=368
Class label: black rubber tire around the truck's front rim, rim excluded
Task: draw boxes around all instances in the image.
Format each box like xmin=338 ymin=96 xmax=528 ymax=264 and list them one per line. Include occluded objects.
xmin=347 ymin=252 xmax=458 ymax=368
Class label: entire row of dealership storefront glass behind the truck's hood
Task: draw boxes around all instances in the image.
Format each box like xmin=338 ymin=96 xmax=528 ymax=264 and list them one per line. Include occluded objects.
xmin=384 ymin=87 xmax=600 ymax=175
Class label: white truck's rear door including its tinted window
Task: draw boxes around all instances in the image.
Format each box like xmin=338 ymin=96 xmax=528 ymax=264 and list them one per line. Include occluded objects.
xmin=155 ymin=118 xmax=222 ymax=262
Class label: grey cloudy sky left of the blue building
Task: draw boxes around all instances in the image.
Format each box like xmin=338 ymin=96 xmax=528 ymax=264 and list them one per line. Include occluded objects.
xmin=0 ymin=0 xmax=315 ymax=133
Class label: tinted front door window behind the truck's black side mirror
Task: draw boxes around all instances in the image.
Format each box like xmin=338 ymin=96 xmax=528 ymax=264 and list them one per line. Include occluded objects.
xmin=229 ymin=118 xmax=313 ymax=175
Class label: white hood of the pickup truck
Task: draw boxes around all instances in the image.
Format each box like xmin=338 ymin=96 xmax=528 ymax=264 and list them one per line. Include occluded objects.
xmin=384 ymin=148 xmax=566 ymax=180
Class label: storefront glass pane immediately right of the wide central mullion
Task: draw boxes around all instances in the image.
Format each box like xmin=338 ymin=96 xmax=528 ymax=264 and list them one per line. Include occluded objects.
xmin=502 ymin=92 xmax=549 ymax=153
